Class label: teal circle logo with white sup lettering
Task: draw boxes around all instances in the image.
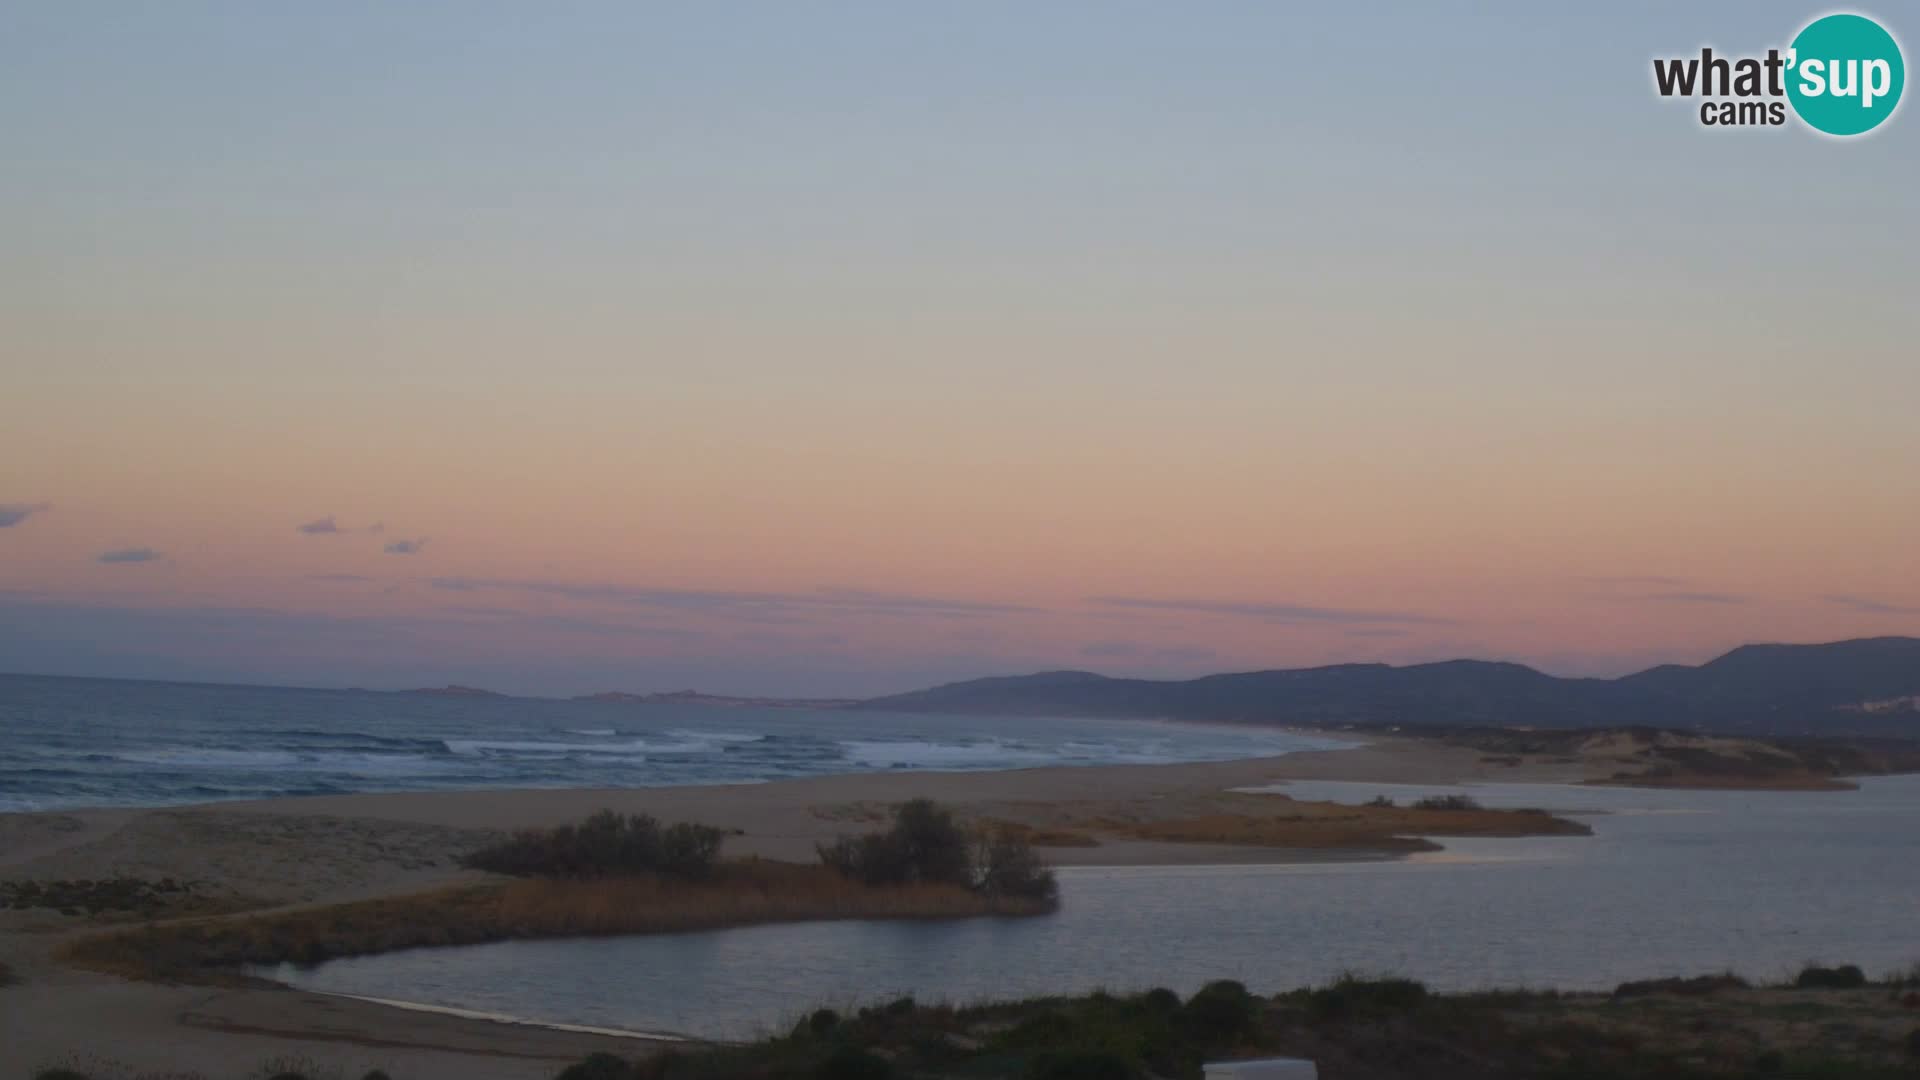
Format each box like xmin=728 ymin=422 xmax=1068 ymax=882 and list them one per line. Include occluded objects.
xmin=1788 ymin=15 xmax=1907 ymax=136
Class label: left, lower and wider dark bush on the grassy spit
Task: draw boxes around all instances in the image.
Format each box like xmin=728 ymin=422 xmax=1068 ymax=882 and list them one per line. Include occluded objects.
xmin=461 ymin=811 xmax=726 ymax=878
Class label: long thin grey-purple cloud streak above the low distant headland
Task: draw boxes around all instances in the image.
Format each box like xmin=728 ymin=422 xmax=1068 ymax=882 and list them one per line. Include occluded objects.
xmin=428 ymin=578 xmax=1037 ymax=617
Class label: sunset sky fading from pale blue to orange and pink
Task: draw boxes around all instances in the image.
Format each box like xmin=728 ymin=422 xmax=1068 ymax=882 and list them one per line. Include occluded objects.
xmin=0 ymin=2 xmax=1920 ymax=696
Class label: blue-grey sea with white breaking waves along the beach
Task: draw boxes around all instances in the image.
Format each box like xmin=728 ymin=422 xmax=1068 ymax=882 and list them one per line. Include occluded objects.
xmin=0 ymin=676 xmax=1344 ymax=811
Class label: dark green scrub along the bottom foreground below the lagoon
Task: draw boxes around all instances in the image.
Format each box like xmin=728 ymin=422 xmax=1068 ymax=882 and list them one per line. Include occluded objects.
xmin=35 ymin=965 xmax=1920 ymax=1080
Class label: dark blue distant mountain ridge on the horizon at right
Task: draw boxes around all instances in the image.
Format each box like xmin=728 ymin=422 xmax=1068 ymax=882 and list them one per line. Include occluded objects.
xmin=858 ymin=638 xmax=1920 ymax=738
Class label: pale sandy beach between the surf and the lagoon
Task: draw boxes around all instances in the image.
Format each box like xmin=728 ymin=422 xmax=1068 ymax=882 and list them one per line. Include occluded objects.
xmin=0 ymin=738 xmax=1820 ymax=1080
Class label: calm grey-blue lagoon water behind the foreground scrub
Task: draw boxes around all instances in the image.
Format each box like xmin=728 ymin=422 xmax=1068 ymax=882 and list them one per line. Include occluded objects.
xmin=263 ymin=776 xmax=1920 ymax=1038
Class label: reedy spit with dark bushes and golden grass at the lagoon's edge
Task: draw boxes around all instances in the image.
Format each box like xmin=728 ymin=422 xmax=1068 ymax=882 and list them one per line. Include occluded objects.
xmin=61 ymin=799 xmax=1058 ymax=982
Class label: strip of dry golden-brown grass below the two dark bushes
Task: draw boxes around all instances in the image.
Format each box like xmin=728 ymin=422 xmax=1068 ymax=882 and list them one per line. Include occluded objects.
xmin=63 ymin=861 xmax=1052 ymax=980
